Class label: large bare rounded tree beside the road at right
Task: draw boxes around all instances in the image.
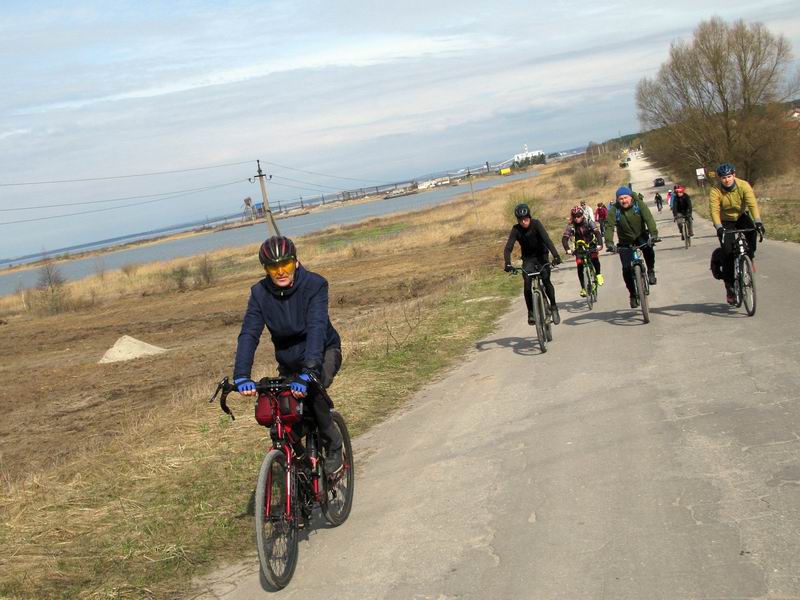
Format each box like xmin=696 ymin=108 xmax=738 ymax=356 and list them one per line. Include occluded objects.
xmin=636 ymin=18 xmax=800 ymax=181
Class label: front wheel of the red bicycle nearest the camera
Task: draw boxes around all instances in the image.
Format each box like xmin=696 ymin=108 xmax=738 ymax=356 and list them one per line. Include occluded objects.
xmin=255 ymin=450 xmax=298 ymax=590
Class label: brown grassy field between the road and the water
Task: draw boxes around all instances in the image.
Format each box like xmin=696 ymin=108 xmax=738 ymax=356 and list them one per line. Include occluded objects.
xmin=0 ymin=161 xmax=621 ymax=599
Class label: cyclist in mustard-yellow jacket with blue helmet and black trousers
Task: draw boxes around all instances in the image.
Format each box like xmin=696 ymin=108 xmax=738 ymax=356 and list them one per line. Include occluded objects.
xmin=708 ymin=163 xmax=766 ymax=304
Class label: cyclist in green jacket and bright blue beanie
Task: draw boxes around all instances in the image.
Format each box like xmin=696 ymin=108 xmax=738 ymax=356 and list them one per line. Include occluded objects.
xmin=605 ymin=187 xmax=659 ymax=308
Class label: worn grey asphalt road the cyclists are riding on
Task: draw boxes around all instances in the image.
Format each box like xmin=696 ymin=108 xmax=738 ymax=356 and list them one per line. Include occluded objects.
xmin=190 ymin=160 xmax=800 ymax=600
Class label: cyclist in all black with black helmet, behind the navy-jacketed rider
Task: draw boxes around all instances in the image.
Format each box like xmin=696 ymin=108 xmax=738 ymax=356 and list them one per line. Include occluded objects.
xmin=503 ymin=204 xmax=561 ymax=325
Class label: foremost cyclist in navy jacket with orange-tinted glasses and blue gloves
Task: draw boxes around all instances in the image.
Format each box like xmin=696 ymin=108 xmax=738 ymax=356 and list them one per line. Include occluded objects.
xmin=233 ymin=236 xmax=342 ymax=474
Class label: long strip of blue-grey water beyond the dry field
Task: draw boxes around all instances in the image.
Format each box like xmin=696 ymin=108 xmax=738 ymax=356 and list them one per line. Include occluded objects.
xmin=0 ymin=173 xmax=536 ymax=295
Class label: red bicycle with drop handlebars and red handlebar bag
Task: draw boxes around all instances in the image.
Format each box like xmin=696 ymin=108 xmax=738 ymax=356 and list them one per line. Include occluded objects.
xmin=210 ymin=375 xmax=355 ymax=589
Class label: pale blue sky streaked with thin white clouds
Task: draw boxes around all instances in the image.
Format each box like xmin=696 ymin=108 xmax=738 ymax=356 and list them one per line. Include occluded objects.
xmin=0 ymin=0 xmax=800 ymax=259
